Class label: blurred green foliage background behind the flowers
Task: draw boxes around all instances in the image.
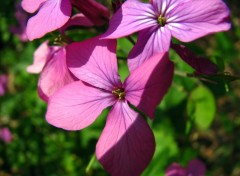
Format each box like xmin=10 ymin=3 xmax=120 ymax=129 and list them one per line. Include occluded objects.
xmin=0 ymin=0 xmax=240 ymax=176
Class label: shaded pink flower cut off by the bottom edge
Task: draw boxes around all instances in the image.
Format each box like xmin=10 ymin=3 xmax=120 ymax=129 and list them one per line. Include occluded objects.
xmin=166 ymin=159 xmax=206 ymax=176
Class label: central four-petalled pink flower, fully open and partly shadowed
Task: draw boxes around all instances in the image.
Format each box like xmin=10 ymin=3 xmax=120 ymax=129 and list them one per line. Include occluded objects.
xmin=46 ymin=37 xmax=173 ymax=176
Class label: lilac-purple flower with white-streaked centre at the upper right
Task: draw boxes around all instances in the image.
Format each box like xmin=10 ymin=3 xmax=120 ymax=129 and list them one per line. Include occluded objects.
xmin=103 ymin=0 xmax=230 ymax=70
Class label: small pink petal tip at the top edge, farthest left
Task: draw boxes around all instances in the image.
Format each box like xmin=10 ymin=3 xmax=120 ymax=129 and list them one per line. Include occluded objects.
xmin=21 ymin=0 xmax=46 ymax=13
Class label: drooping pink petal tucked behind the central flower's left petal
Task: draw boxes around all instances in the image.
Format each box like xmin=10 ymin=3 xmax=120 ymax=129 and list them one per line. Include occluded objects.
xmin=38 ymin=48 xmax=76 ymax=101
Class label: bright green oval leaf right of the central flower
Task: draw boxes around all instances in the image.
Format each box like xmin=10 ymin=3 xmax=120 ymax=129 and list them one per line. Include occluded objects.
xmin=187 ymin=86 xmax=216 ymax=129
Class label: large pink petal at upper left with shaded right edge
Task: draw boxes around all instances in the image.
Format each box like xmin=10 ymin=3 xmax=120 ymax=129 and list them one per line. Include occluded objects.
xmin=27 ymin=0 xmax=72 ymax=40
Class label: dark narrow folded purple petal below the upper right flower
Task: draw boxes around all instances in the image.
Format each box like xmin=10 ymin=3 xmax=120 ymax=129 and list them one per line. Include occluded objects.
xmin=172 ymin=44 xmax=217 ymax=75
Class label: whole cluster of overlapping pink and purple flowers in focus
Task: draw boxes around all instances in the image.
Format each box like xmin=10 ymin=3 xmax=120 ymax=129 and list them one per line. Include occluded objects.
xmin=21 ymin=0 xmax=230 ymax=176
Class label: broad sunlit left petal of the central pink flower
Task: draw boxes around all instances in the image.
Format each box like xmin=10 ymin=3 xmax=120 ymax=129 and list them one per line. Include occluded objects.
xmin=46 ymin=81 xmax=115 ymax=130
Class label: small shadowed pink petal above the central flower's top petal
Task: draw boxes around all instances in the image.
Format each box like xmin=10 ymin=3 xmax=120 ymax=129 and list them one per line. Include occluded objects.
xmin=60 ymin=13 xmax=94 ymax=33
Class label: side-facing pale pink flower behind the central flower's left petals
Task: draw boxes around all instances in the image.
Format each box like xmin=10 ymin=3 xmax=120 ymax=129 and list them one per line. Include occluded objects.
xmin=27 ymin=41 xmax=76 ymax=102
